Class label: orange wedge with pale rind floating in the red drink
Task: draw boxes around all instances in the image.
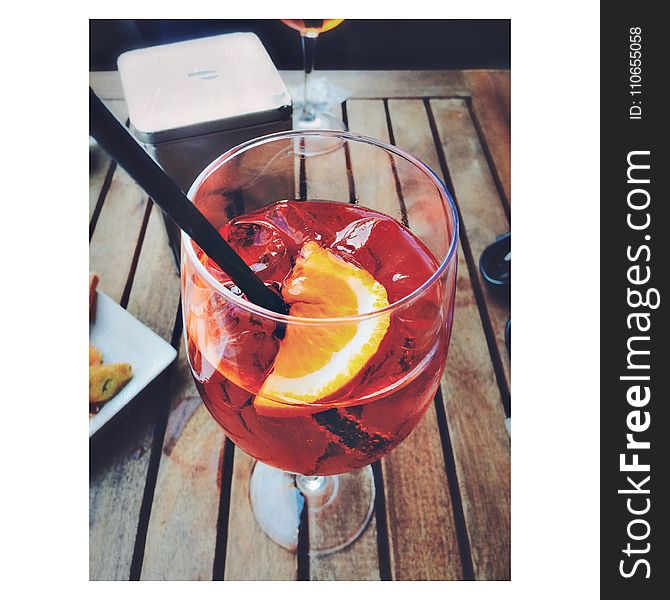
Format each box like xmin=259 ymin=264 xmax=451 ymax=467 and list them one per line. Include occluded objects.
xmin=254 ymin=241 xmax=390 ymax=416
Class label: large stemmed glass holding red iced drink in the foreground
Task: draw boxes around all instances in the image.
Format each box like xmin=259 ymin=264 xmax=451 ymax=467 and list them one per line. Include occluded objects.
xmin=181 ymin=130 xmax=458 ymax=555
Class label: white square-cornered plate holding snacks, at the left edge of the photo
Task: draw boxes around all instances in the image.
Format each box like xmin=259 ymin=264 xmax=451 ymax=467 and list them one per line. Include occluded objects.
xmin=88 ymin=292 xmax=177 ymax=437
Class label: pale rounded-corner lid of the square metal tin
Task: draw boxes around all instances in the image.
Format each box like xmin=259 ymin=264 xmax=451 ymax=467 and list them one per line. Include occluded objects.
xmin=117 ymin=33 xmax=291 ymax=144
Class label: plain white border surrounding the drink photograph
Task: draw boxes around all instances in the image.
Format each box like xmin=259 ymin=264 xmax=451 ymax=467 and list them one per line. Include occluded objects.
xmin=5 ymin=0 xmax=599 ymax=600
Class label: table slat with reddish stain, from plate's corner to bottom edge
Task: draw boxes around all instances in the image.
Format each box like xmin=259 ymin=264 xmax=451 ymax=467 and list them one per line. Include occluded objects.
xmin=141 ymin=337 xmax=225 ymax=580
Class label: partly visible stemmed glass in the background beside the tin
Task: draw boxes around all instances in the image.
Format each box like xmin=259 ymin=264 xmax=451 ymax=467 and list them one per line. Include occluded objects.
xmin=281 ymin=19 xmax=347 ymax=131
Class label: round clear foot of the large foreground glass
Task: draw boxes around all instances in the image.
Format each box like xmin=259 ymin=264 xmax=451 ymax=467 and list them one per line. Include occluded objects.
xmin=249 ymin=462 xmax=375 ymax=556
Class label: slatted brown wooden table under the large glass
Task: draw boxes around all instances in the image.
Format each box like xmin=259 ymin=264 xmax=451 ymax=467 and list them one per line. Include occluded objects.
xmin=89 ymin=71 xmax=510 ymax=580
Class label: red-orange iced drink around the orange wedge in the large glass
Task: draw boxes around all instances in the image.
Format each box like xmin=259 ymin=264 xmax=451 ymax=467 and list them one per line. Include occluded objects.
xmin=182 ymin=201 xmax=455 ymax=475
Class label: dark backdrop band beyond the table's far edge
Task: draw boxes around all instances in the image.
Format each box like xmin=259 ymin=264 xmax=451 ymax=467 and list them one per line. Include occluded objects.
xmin=89 ymin=19 xmax=510 ymax=71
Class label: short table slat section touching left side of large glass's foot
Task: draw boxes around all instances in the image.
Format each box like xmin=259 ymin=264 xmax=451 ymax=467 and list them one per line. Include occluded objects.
xmin=224 ymin=448 xmax=298 ymax=581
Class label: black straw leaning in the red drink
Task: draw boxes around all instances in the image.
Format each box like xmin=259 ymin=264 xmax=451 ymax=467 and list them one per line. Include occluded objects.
xmin=89 ymin=87 xmax=288 ymax=314
